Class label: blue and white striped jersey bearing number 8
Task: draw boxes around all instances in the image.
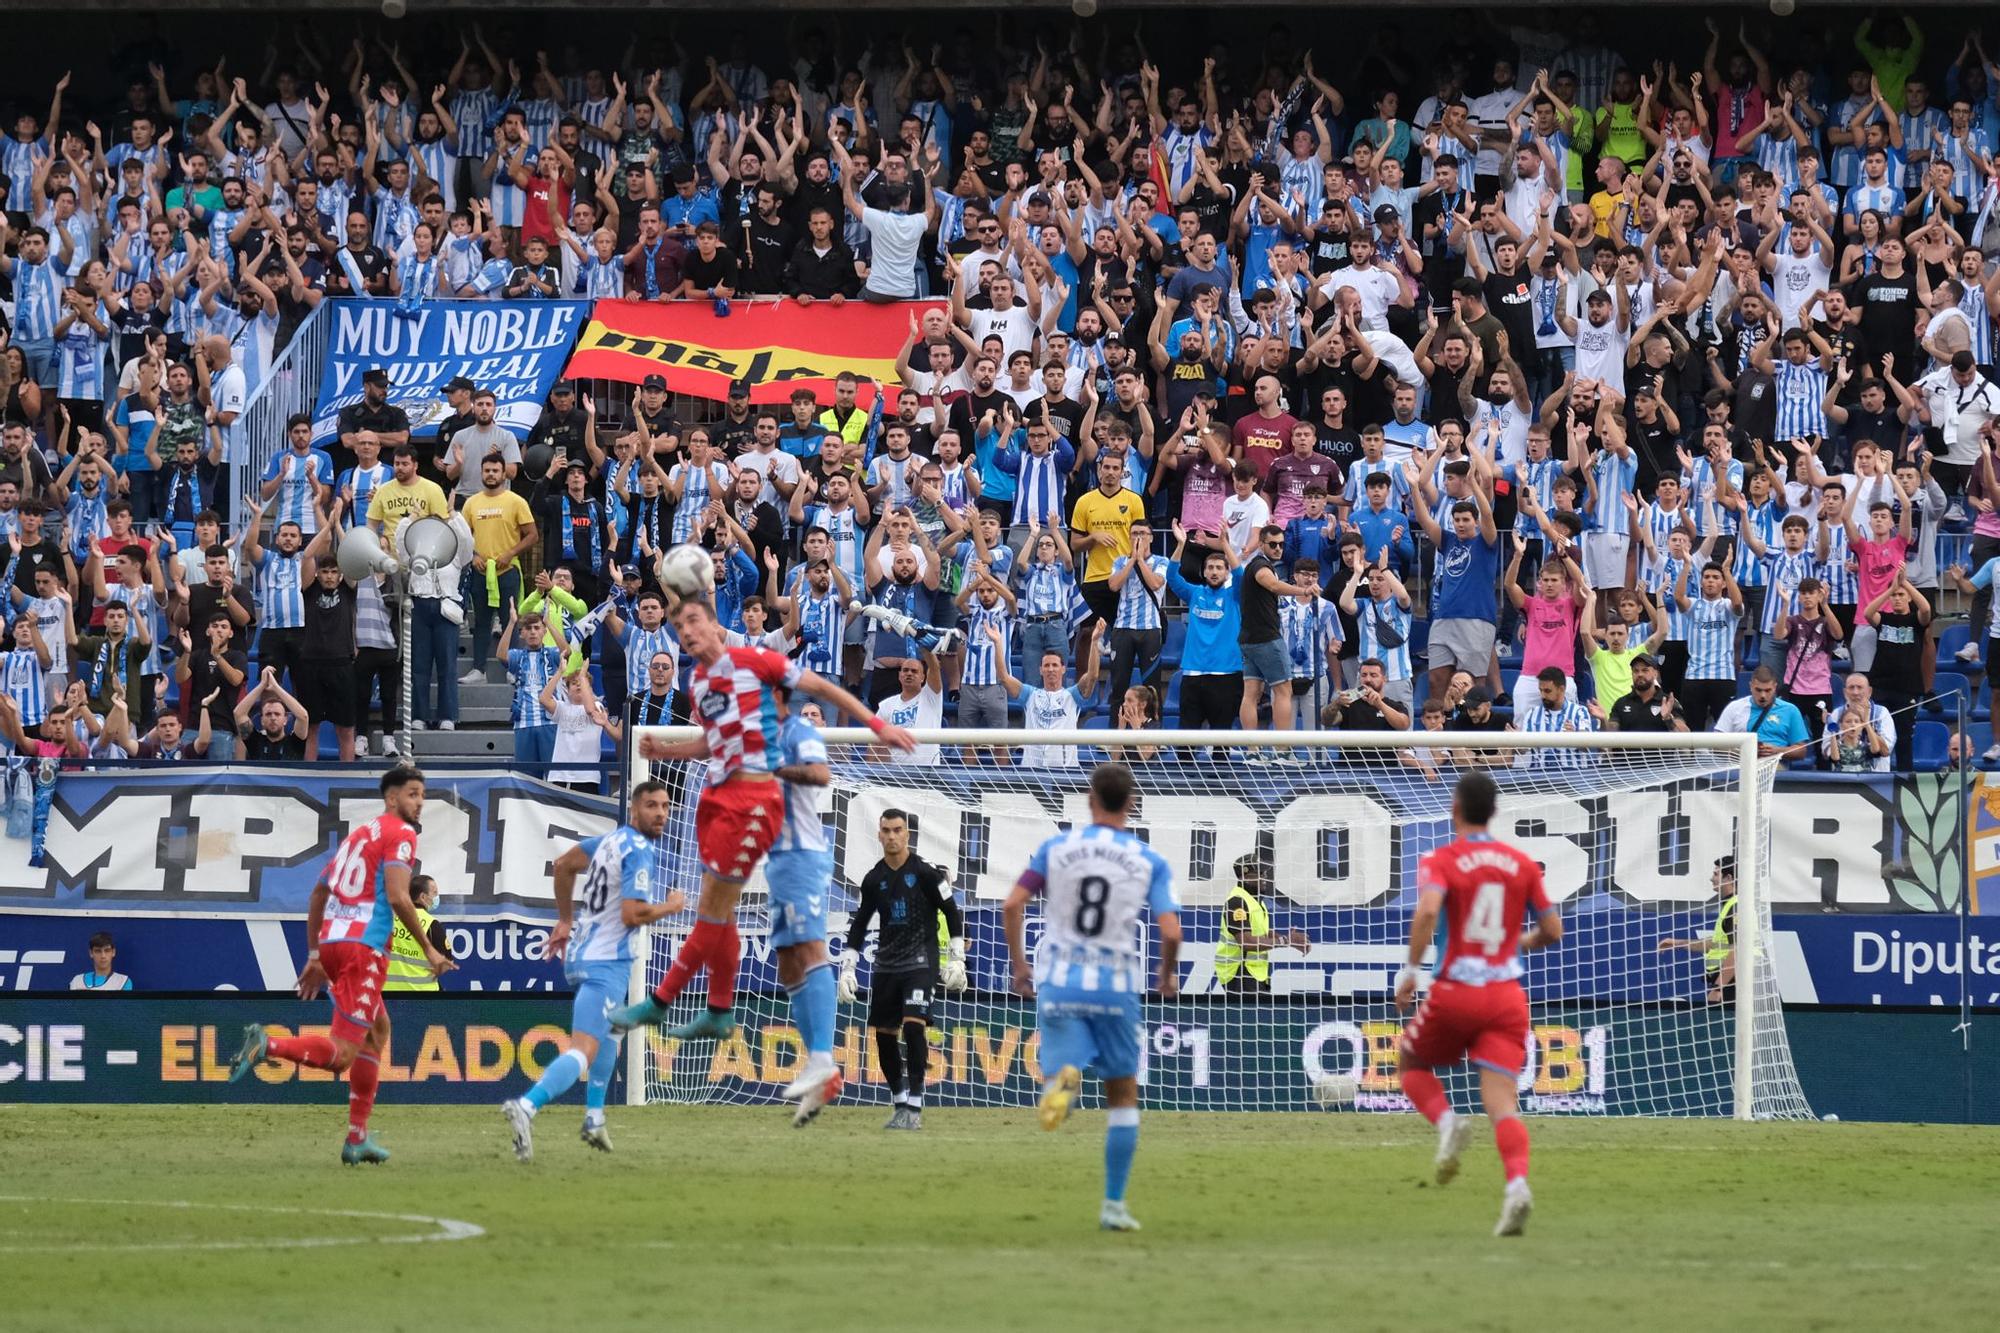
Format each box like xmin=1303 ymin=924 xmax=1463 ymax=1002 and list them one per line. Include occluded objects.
xmin=1022 ymin=825 xmax=1180 ymax=993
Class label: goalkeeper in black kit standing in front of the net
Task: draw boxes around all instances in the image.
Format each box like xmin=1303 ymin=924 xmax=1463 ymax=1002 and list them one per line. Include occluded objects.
xmin=838 ymin=811 xmax=966 ymax=1129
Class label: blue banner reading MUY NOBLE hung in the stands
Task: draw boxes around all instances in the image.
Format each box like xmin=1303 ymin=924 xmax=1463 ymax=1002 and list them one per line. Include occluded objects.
xmin=312 ymin=300 xmax=590 ymax=446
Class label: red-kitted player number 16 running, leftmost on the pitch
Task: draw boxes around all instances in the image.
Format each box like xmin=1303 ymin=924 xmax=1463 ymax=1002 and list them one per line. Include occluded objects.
xmin=230 ymin=765 xmax=458 ymax=1167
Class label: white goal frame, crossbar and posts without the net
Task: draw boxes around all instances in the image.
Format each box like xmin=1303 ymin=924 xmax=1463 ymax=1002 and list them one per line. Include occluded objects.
xmin=618 ymin=727 xmax=1772 ymax=1121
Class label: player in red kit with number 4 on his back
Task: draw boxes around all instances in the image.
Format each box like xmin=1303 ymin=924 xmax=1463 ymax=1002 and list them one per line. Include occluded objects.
xmin=1396 ymin=773 xmax=1562 ymax=1235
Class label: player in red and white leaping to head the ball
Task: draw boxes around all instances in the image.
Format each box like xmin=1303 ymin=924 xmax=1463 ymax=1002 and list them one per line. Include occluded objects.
xmin=612 ymin=598 xmax=916 ymax=1039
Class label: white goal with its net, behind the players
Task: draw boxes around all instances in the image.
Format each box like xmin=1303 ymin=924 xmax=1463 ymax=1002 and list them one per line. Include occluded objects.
xmin=626 ymin=729 xmax=1810 ymax=1119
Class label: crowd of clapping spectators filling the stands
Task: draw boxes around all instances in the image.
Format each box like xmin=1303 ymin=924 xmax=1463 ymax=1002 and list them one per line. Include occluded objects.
xmin=0 ymin=10 xmax=2000 ymax=783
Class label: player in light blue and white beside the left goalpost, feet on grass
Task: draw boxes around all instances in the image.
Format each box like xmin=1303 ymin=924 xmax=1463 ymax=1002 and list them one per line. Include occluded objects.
xmin=500 ymin=781 xmax=688 ymax=1161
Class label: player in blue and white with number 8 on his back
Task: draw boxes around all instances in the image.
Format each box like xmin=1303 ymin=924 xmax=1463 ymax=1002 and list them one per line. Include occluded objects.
xmin=1004 ymin=763 xmax=1180 ymax=1231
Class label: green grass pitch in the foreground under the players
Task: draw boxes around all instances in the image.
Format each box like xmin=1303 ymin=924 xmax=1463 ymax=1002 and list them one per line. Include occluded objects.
xmin=0 ymin=1103 xmax=2000 ymax=1333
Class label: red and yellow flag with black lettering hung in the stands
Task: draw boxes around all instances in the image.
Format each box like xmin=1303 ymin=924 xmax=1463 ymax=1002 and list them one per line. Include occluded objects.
xmin=564 ymin=300 xmax=942 ymax=404
